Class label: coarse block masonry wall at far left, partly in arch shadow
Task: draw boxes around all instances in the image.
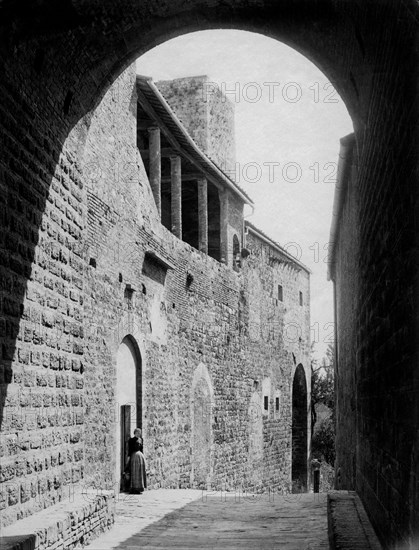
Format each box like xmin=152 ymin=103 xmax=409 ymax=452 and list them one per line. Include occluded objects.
xmin=0 ymin=64 xmax=85 ymax=523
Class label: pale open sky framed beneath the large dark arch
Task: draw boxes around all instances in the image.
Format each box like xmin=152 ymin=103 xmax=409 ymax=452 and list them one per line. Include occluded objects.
xmin=137 ymin=30 xmax=353 ymax=359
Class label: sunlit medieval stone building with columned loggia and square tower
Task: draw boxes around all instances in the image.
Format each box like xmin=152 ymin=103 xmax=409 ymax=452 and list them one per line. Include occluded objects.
xmin=1 ymin=63 xmax=310 ymax=536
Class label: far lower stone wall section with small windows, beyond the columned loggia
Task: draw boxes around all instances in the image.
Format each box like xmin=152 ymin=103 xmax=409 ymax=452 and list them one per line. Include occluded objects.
xmin=240 ymin=231 xmax=311 ymax=487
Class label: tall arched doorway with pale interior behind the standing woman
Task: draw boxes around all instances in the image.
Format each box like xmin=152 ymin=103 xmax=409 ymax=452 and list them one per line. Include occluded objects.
xmin=115 ymin=336 xmax=142 ymax=489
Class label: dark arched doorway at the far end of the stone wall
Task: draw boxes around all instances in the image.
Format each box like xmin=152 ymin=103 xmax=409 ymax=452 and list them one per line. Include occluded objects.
xmin=291 ymin=365 xmax=308 ymax=493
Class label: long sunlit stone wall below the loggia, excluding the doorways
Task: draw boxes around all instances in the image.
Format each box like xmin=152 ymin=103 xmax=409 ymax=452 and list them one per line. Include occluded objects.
xmin=2 ymin=62 xmax=309 ymax=524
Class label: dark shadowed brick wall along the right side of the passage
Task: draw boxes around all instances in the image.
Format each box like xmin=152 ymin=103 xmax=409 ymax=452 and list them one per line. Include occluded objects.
xmin=336 ymin=3 xmax=419 ymax=548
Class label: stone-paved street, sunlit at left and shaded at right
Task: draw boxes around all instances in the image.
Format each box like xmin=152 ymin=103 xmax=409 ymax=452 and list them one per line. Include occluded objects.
xmin=86 ymin=489 xmax=329 ymax=550
